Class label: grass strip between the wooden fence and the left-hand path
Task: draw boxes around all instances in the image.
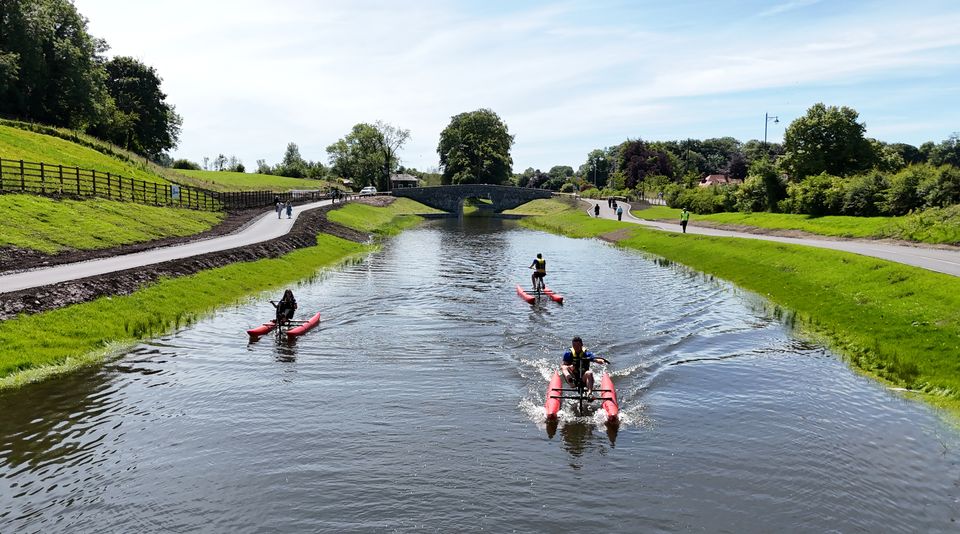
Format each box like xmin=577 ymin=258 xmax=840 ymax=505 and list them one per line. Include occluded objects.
xmin=0 ymin=195 xmax=224 ymax=254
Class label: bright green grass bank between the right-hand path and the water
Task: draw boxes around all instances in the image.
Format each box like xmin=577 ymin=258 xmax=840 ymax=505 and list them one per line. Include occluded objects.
xmin=523 ymin=203 xmax=960 ymax=415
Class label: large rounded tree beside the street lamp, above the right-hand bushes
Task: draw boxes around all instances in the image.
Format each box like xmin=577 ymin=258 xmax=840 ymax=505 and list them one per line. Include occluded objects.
xmin=782 ymin=103 xmax=876 ymax=180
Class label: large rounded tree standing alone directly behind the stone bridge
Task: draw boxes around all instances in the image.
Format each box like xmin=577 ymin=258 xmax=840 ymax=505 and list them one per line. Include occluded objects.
xmin=437 ymin=109 xmax=513 ymax=184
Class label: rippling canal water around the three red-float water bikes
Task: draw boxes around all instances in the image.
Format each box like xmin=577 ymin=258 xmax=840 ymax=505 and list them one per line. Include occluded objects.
xmin=0 ymin=219 xmax=960 ymax=533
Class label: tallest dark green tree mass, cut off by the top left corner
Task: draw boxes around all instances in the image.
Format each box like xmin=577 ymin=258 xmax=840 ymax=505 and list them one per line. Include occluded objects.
xmin=0 ymin=0 xmax=109 ymax=129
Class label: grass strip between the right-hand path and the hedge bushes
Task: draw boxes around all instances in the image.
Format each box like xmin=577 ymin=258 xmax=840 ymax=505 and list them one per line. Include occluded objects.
xmin=631 ymin=205 xmax=960 ymax=245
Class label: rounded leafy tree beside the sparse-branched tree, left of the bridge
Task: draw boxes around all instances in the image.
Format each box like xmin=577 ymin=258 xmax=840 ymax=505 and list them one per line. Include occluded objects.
xmin=327 ymin=122 xmax=386 ymax=187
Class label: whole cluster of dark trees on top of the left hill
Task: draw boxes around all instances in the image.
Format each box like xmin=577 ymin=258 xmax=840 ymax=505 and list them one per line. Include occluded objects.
xmin=0 ymin=0 xmax=182 ymax=161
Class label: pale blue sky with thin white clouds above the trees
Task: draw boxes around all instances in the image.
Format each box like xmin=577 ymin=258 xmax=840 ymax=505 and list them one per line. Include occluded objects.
xmin=74 ymin=0 xmax=960 ymax=172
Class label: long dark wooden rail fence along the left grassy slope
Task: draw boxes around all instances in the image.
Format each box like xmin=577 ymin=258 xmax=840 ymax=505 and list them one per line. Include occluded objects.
xmin=0 ymin=158 xmax=330 ymax=211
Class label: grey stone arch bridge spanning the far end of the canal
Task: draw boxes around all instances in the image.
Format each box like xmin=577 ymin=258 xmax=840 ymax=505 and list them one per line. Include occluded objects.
xmin=393 ymin=184 xmax=551 ymax=213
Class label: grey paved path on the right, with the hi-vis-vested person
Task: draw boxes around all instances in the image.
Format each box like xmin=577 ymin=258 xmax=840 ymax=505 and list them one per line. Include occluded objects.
xmin=582 ymin=198 xmax=960 ymax=276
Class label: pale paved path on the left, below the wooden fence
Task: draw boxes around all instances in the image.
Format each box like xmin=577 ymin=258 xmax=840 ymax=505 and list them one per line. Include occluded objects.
xmin=0 ymin=200 xmax=332 ymax=294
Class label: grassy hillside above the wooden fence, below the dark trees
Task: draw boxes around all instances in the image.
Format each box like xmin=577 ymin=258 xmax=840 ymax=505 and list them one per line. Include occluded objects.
xmin=0 ymin=124 xmax=169 ymax=184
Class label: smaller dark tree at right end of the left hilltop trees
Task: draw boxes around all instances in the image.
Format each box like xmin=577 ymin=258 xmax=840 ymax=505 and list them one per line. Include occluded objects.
xmin=95 ymin=57 xmax=183 ymax=157
